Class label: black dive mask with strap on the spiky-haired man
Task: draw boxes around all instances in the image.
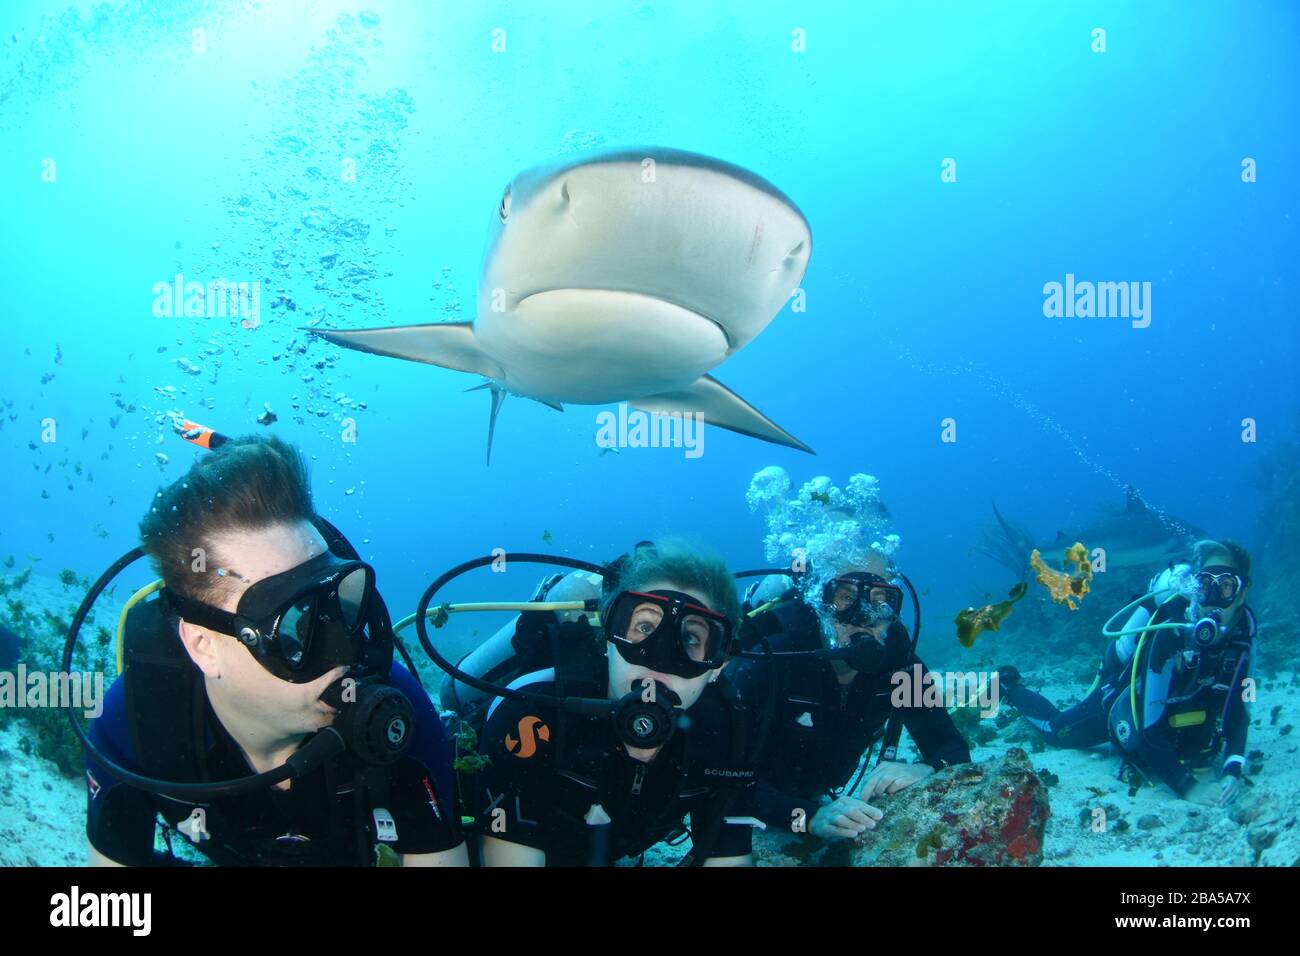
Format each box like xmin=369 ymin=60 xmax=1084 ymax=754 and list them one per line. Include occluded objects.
xmin=168 ymin=551 xmax=379 ymax=684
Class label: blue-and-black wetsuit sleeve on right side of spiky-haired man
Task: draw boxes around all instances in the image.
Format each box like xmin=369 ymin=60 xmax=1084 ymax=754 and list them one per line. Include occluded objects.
xmin=386 ymin=663 xmax=464 ymax=855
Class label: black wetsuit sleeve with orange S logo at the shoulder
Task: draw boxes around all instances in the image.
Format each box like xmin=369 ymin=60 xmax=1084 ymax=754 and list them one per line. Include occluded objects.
xmin=467 ymin=683 xmax=555 ymax=851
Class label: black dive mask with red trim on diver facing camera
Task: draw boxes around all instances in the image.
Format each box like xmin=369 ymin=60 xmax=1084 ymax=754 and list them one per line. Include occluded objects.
xmin=605 ymin=591 xmax=732 ymax=679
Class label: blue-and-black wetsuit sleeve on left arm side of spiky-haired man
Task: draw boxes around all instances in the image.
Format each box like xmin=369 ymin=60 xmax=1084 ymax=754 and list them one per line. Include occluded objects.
xmin=86 ymin=678 xmax=164 ymax=866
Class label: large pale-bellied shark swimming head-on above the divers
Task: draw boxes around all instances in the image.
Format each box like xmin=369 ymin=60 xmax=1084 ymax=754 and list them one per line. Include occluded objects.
xmin=308 ymin=147 xmax=815 ymax=463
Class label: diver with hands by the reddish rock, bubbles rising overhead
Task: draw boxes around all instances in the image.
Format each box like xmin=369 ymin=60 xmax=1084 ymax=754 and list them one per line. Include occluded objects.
xmin=736 ymin=567 xmax=971 ymax=839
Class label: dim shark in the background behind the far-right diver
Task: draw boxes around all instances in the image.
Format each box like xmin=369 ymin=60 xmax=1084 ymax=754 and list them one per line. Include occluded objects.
xmin=975 ymin=486 xmax=1206 ymax=576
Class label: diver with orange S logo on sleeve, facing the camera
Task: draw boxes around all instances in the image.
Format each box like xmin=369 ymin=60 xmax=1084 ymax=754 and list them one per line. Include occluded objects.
xmin=436 ymin=541 xmax=753 ymax=866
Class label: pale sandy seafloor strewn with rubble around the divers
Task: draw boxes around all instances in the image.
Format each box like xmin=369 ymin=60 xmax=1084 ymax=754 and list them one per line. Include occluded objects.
xmin=0 ymin=575 xmax=1300 ymax=866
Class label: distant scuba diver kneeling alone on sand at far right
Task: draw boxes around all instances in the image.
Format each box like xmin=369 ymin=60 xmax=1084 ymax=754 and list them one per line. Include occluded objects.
xmin=998 ymin=540 xmax=1256 ymax=806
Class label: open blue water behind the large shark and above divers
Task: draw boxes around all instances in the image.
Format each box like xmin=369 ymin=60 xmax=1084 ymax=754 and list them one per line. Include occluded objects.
xmin=0 ymin=0 xmax=1300 ymax=665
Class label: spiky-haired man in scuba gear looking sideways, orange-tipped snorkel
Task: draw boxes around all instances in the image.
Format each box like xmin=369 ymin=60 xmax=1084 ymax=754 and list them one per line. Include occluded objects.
xmin=79 ymin=437 xmax=468 ymax=866
